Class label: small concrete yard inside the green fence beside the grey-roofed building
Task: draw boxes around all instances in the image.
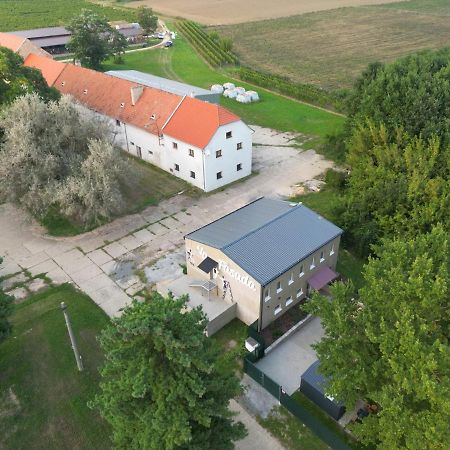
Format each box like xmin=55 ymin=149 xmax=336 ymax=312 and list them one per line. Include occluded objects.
xmin=256 ymin=317 xmax=323 ymax=395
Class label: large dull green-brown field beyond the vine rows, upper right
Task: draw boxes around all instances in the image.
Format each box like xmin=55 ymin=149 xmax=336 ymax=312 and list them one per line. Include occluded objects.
xmin=216 ymin=0 xmax=450 ymax=90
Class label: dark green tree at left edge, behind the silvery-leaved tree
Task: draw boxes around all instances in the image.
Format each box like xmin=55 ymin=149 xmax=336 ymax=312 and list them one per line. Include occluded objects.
xmin=0 ymin=47 xmax=59 ymax=106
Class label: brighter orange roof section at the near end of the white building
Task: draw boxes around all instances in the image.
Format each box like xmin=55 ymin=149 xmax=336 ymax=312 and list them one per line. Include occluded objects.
xmin=164 ymin=97 xmax=240 ymax=149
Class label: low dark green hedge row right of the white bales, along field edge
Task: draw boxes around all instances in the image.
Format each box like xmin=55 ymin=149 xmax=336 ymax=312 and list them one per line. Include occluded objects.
xmin=239 ymin=67 xmax=342 ymax=111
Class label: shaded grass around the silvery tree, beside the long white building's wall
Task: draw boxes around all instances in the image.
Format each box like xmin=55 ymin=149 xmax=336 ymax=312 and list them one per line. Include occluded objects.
xmin=40 ymin=152 xmax=201 ymax=236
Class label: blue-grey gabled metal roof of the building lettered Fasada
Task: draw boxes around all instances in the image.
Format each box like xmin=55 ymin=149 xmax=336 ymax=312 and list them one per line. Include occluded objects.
xmin=187 ymin=198 xmax=342 ymax=286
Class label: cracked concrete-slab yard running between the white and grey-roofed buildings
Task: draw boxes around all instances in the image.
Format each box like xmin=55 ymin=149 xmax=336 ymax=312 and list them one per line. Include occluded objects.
xmin=0 ymin=127 xmax=332 ymax=316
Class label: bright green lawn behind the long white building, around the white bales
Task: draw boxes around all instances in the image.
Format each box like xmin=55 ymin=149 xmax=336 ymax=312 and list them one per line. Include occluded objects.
xmin=104 ymin=29 xmax=344 ymax=138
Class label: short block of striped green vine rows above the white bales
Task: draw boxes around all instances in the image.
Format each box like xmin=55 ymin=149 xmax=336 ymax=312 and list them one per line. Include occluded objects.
xmin=178 ymin=21 xmax=237 ymax=66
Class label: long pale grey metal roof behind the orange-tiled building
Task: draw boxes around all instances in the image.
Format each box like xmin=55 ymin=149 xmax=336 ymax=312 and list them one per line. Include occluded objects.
xmin=106 ymin=70 xmax=213 ymax=97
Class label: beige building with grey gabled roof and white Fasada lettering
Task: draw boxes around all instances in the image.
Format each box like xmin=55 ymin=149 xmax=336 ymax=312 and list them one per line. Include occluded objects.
xmin=185 ymin=198 xmax=343 ymax=329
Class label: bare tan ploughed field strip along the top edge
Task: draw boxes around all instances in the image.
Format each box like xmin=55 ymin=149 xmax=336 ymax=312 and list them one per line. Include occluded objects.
xmin=127 ymin=0 xmax=408 ymax=25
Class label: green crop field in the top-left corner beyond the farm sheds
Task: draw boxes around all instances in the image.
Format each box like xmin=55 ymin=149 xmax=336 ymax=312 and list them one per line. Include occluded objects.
xmin=0 ymin=0 xmax=136 ymax=31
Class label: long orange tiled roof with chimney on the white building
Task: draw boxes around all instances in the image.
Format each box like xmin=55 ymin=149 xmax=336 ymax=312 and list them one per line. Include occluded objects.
xmin=19 ymin=55 xmax=240 ymax=149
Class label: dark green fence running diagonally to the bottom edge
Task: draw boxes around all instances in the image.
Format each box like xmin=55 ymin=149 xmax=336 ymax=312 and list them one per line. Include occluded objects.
xmin=244 ymin=353 xmax=352 ymax=450
